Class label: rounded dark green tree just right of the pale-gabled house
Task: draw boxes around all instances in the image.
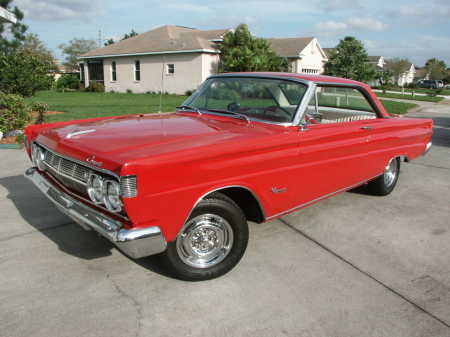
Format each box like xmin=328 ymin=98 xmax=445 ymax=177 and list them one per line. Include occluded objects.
xmin=324 ymin=36 xmax=376 ymax=83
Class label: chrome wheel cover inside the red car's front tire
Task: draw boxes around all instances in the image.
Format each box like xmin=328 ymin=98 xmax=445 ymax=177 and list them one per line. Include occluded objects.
xmin=176 ymin=214 xmax=233 ymax=268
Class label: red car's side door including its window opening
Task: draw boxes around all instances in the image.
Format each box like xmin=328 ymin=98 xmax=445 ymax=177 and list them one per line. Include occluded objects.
xmin=297 ymin=87 xmax=370 ymax=205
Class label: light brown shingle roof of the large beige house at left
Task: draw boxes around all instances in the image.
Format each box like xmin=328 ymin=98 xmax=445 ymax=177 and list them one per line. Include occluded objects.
xmin=78 ymin=25 xmax=229 ymax=59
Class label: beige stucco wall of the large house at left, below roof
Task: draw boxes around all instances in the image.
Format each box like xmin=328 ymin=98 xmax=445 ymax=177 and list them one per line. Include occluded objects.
xmin=85 ymin=53 xmax=218 ymax=95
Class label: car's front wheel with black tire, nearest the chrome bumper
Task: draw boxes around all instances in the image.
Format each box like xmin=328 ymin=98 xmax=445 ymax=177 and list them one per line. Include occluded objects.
xmin=162 ymin=193 xmax=249 ymax=281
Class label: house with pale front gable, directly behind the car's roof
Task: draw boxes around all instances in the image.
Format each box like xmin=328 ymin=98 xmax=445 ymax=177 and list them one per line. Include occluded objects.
xmin=269 ymin=37 xmax=328 ymax=74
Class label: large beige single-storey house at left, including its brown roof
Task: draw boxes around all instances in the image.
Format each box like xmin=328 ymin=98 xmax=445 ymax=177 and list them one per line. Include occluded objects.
xmin=79 ymin=25 xmax=229 ymax=95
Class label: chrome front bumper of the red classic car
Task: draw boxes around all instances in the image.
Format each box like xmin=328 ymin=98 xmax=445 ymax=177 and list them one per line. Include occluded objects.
xmin=24 ymin=167 xmax=167 ymax=259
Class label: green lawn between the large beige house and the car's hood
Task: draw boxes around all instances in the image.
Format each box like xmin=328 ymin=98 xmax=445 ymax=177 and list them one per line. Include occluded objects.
xmin=25 ymin=90 xmax=188 ymax=122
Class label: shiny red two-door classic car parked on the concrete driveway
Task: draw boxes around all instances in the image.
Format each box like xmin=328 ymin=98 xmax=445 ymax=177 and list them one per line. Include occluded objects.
xmin=25 ymin=73 xmax=432 ymax=280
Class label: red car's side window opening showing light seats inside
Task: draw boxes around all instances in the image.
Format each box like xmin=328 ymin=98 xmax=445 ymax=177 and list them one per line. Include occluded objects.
xmin=308 ymin=86 xmax=377 ymax=124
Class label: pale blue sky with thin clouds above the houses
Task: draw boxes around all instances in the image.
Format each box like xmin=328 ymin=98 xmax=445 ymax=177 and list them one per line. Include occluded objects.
xmin=7 ymin=0 xmax=450 ymax=67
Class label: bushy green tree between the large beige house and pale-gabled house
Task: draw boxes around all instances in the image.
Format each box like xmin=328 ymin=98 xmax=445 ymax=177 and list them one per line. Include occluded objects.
xmin=220 ymin=24 xmax=289 ymax=72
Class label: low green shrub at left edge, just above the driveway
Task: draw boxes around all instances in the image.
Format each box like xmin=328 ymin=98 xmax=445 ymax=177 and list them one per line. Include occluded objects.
xmin=0 ymin=94 xmax=31 ymax=134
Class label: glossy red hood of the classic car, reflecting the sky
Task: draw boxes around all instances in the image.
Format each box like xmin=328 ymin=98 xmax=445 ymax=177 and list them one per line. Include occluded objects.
xmin=37 ymin=113 xmax=288 ymax=171
